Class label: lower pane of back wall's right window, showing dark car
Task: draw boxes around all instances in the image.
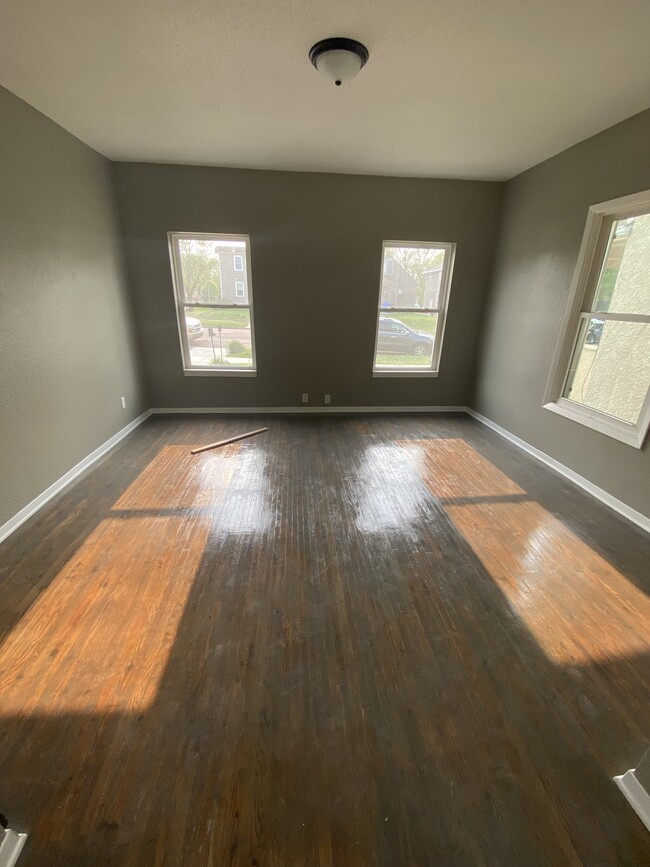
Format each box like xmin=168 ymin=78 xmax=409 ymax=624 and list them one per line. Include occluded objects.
xmin=375 ymin=312 xmax=438 ymax=369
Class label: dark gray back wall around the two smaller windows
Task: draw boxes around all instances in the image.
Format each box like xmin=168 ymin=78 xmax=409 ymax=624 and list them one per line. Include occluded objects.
xmin=115 ymin=163 xmax=503 ymax=407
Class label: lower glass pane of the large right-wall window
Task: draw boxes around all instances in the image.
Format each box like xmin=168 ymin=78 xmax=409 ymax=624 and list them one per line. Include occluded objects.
xmin=563 ymin=318 xmax=650 ymax=424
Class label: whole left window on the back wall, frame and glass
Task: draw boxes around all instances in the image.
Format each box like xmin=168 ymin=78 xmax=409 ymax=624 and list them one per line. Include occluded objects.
xmin=169 ymin=232 xmax=256 ymax=375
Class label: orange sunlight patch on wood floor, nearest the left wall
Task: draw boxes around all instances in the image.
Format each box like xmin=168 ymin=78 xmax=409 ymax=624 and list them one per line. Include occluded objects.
xmin=0 ymin=446 xmax=225 ymax=716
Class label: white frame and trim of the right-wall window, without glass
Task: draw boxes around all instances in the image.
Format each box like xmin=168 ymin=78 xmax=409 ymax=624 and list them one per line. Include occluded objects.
xmin=544 ymin=190 xmax=650 ymax=449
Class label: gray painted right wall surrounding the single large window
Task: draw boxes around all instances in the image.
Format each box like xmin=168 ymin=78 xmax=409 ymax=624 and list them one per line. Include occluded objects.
xmin=472 ymin=110 xmax=650 ymax=515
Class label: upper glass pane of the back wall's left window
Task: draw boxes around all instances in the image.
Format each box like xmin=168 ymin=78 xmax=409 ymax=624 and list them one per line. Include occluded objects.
xmin=178 ymin=238 xmax=249 ymax=304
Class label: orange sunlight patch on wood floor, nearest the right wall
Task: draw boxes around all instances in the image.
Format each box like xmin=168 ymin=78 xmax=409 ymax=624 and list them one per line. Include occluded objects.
xmin=412 ymin=440 xmax=650 ymax=665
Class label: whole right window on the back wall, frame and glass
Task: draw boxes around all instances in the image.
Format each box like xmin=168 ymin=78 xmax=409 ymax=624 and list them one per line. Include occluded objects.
xmin=373 ymin=241 xmax=456 ymax=376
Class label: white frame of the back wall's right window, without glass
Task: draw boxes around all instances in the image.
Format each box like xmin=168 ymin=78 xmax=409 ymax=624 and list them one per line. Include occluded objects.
xmin=372 ymin=241 xmax=456 ymax=378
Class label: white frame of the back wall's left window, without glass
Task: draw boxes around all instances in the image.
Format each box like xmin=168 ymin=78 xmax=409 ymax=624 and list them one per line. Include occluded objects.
xmin=167 ymin=232 xmax=257 ymax=376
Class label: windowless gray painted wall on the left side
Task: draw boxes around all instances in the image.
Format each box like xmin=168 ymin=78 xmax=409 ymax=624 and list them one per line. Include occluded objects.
xmin=0 ymin=88 xmax=145 ymax=525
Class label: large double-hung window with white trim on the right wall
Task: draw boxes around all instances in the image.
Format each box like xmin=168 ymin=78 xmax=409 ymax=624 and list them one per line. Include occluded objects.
xmin=544 ymin=190 xmax=650 ymax=448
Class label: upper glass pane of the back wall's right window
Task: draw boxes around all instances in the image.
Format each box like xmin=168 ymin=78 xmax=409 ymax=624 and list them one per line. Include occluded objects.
xmin=379 ymin=247 xmax=445 ymax=308
